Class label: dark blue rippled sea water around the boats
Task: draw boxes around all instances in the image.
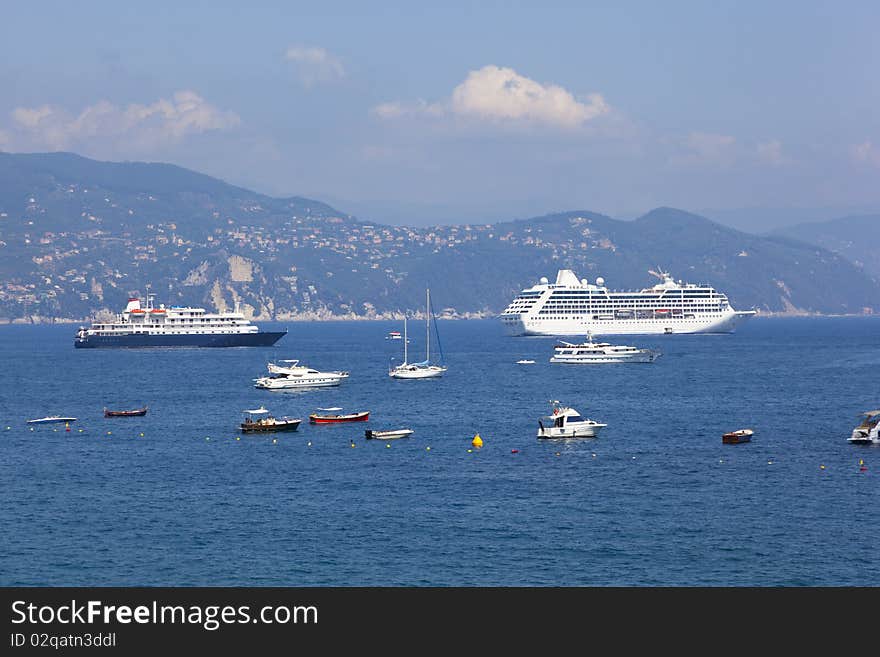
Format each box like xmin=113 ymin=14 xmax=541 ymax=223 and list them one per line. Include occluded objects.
xmin=0 ymin=318 xmax=880 ymax=586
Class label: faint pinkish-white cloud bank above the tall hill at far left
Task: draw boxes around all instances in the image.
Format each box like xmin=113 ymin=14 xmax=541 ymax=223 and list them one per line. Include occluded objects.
xmin=10 ymin=91 xmax=241 ymax=150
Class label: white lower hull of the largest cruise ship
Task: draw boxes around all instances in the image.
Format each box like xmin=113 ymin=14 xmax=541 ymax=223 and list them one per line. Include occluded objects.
xmin=502 ymin=310 xmax=755 ymax=336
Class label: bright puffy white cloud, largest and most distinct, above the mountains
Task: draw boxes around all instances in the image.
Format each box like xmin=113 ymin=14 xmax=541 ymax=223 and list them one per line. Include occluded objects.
xmin=373 ymin=66 xmax=611 ymax=129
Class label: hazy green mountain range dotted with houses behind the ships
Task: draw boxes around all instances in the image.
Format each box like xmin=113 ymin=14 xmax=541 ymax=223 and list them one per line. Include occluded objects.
xmin=0 ymin=153 xmax=880 ymax=321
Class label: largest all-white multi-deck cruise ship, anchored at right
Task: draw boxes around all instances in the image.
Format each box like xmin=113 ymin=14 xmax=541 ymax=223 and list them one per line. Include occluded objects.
xmin=501 ymin=269 xmax=755 ymax=335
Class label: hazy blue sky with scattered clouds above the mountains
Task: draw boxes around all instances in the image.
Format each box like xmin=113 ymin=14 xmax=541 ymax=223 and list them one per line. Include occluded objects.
xmin=0 ymin=0 xmax=880 ymax=230
